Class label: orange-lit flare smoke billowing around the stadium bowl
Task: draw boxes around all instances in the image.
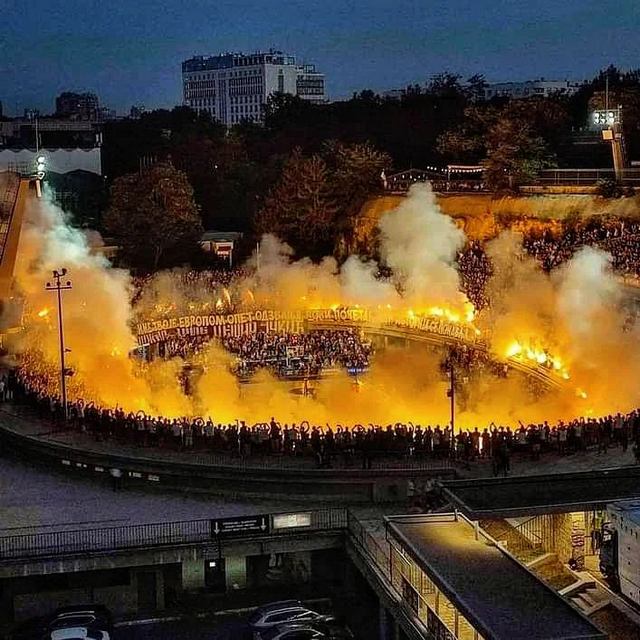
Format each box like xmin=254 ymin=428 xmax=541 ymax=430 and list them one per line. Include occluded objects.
xmin=8 ymin=185 xmax=640 ymax=426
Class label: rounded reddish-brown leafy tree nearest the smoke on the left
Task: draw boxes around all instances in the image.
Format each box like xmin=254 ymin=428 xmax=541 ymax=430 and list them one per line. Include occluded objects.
xmin=105 ymin=164 xmax=202 ymax=271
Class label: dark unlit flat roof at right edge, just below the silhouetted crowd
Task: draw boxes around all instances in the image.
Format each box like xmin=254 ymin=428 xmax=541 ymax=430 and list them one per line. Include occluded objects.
xmin=442 ymin=467 xmax=640 ymax=519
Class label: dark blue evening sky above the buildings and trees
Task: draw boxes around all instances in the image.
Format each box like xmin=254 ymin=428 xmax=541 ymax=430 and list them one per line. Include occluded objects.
xmin=0 ymin=0 xmax=640 ymax=113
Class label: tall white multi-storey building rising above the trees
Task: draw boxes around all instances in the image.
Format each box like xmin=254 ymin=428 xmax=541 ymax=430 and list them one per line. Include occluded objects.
xmin=182 ymin=51 xmax=326 ymax=125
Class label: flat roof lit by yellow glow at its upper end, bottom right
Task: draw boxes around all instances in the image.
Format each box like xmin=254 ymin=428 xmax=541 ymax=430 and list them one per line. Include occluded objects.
xmin=388 ymin=514 xmax=606 ymax=640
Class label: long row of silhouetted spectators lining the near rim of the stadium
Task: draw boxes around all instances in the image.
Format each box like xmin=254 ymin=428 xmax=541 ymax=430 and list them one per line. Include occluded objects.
xmin=8 ymin=364 xmax=640 ymax=475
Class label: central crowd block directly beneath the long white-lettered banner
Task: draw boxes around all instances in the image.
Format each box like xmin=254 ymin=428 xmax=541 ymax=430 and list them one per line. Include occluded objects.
xmin=222 ymin=329 xmax=373 ymax=377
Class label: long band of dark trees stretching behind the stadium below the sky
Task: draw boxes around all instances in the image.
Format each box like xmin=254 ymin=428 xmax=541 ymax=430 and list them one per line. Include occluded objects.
xmin=98 ymin=66 xmax=640 ymax=270
